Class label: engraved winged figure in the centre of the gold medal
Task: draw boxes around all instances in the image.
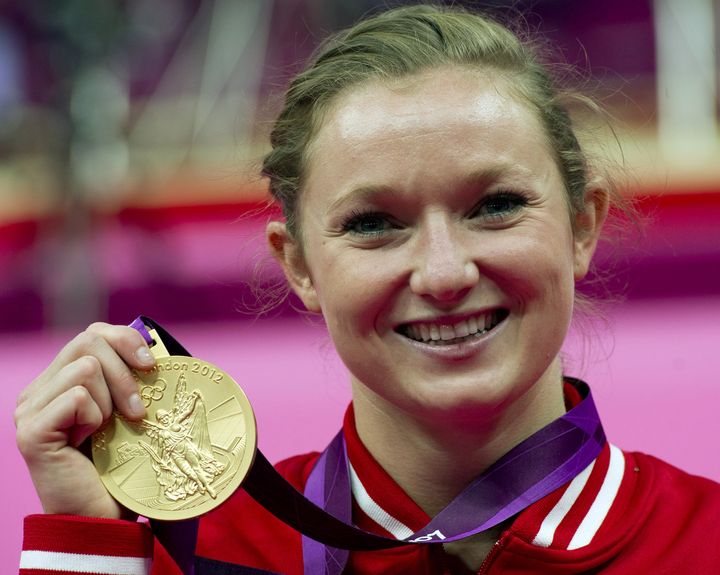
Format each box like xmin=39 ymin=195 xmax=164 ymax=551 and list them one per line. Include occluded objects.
xmin=138 ymin=373 xmax=225 ymax=501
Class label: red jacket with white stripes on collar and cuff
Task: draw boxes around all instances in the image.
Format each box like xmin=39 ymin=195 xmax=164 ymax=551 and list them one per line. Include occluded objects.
xmin=20 ymin=396 xmax=720 ymax=575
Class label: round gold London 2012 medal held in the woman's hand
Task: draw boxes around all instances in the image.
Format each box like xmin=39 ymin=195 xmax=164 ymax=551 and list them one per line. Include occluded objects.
xmin=92 ymin=330 xmax=257 ymax=521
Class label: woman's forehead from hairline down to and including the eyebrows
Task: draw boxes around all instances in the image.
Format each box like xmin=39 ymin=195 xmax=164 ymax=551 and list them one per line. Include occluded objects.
xmin=303 ymin=67 xmax=558 ymax=203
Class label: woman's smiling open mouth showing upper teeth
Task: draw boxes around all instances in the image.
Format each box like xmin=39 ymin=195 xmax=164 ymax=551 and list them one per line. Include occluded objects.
xmin=395 ymin=309 xmax=510 ymax=345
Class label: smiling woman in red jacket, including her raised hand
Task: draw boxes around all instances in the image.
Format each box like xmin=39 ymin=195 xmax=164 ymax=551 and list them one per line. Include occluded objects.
xmin=17 ymin=6 xmax=720 ymax=574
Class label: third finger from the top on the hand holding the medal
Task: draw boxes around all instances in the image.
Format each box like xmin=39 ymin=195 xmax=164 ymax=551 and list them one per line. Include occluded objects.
xmin=15 ymin=355 xmax=113 ymax=425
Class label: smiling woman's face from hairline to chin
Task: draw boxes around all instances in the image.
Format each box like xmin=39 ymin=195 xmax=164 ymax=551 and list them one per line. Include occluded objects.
xmin=271 ymin=68 xmax=595 ymax=417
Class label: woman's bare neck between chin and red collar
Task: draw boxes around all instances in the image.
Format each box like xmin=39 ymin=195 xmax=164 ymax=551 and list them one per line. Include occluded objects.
xmin=353 ymin=360 xmax=565 ymax=517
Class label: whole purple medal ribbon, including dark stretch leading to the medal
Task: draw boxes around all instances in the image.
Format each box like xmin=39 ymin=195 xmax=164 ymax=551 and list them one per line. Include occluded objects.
xmin=126 ymin=316 xmax=606 ymax=575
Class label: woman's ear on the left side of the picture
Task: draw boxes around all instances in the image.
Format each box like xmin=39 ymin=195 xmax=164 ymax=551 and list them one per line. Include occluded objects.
xmin=265 ymin=221 xmax=320 ymax=313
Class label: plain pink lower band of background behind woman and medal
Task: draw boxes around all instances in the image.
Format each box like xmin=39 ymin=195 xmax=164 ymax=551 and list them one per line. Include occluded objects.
xmin=5 ymin=297 xmax=720 ymax=573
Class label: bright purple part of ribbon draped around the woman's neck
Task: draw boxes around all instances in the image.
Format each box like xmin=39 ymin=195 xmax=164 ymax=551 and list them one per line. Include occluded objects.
xmin=302 ymin=378 xmax=606 ymax=575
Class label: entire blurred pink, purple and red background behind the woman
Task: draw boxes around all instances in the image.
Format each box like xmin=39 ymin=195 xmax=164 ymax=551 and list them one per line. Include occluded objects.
xmin=0 ymin=0 xmax=720 ymax=573
